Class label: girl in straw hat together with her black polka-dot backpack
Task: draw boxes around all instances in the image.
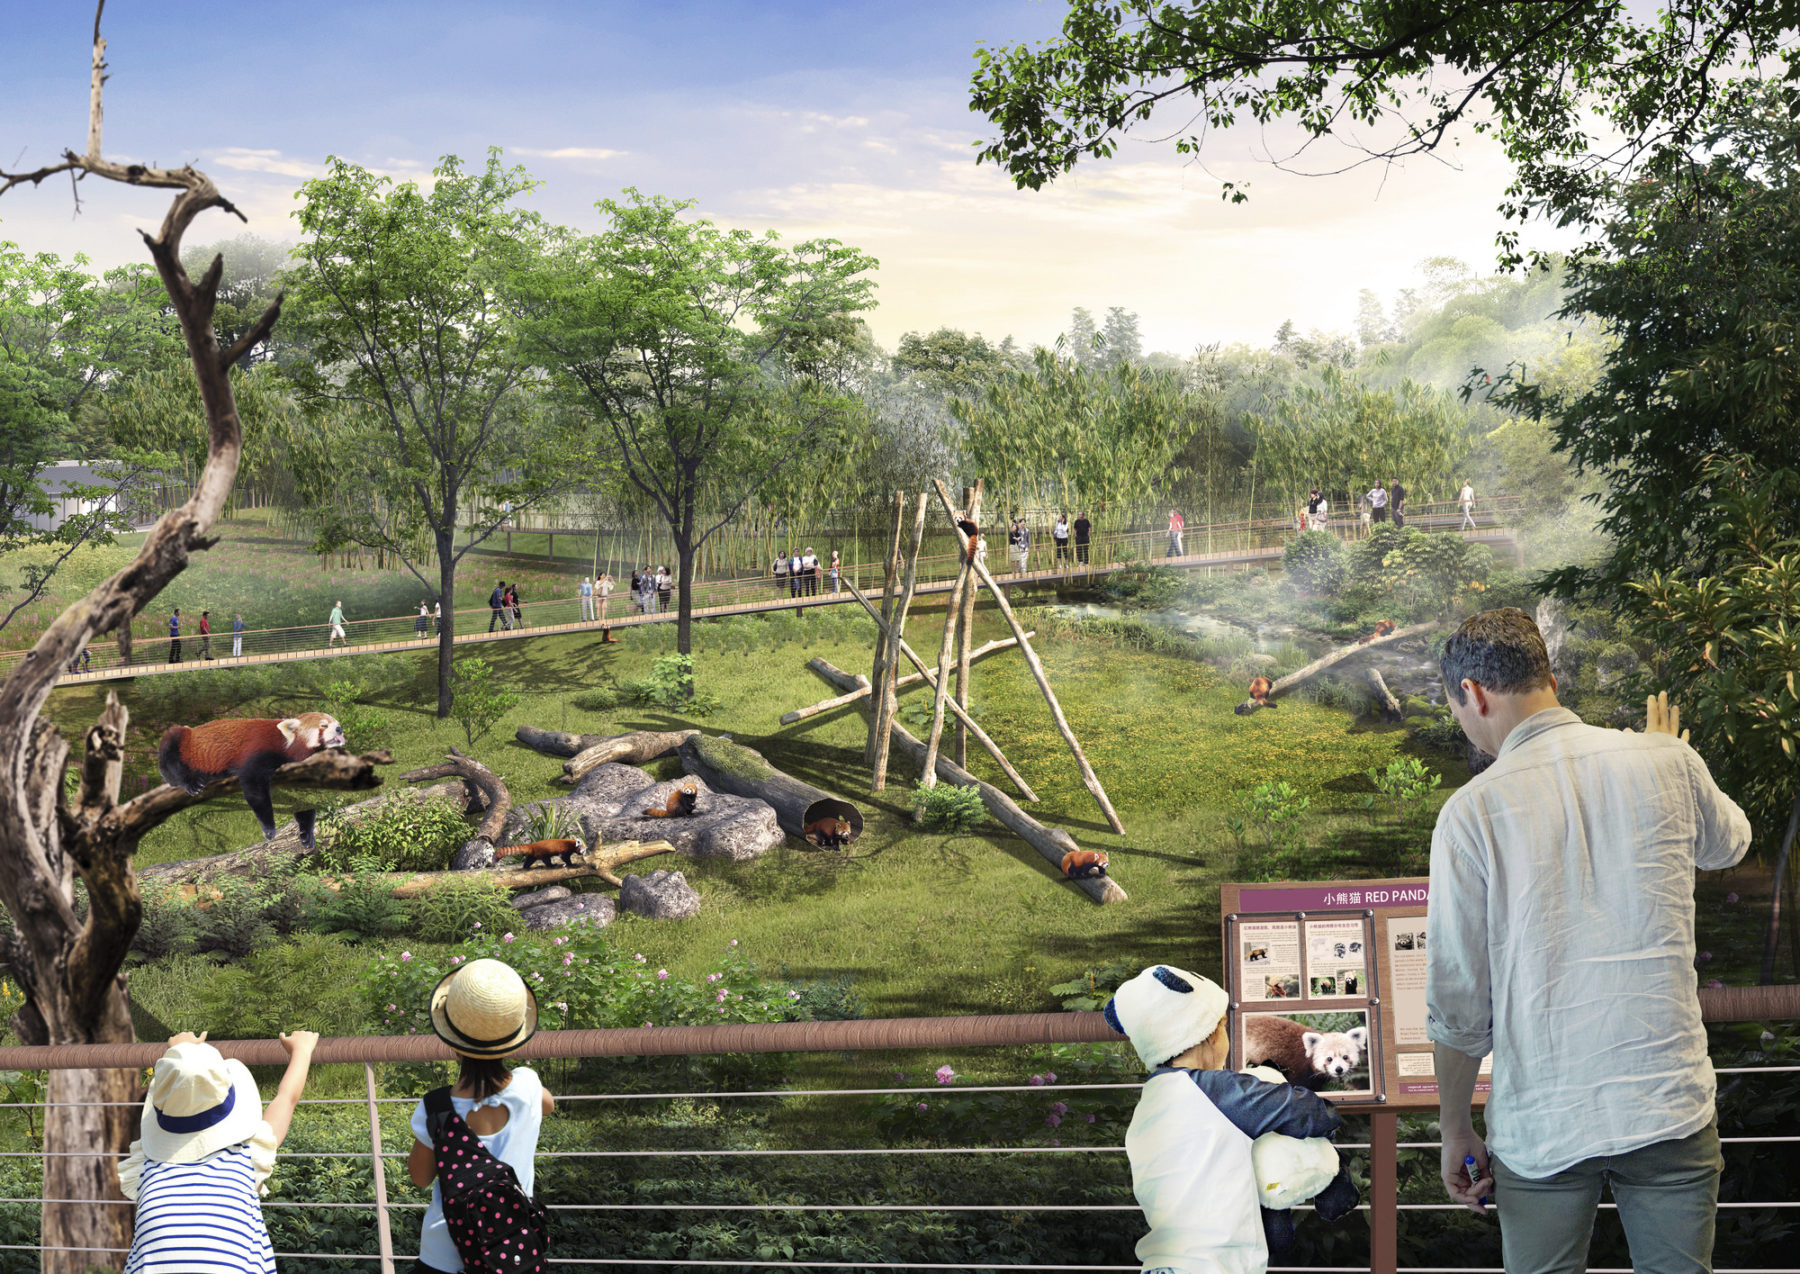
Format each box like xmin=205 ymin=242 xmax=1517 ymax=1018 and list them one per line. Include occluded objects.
xmin=407 ymin=959 xmax=556 ymax=1274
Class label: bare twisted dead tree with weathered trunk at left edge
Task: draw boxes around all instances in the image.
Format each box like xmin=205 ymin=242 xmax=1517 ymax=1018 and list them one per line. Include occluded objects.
xmin=0 ymin=0 xmax=392 ymax=1274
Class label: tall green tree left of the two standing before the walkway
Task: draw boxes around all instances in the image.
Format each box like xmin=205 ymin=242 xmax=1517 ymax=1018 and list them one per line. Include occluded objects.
xmin=284 ymin=149 xmax=565 ymax=718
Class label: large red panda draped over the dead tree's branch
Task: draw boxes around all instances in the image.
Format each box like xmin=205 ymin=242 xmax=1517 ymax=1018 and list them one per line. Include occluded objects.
xmin=157 ymin=713 xmax=344 ymax=849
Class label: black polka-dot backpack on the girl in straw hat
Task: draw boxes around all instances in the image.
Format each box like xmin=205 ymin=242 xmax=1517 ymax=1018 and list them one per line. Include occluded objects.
xmin=425 ymin=1087 xmax=549 ymax=1274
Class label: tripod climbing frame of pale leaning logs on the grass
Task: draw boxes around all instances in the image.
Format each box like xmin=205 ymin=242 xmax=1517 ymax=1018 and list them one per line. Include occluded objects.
xmin=781 ymin=482 xmax=1125 ymax=902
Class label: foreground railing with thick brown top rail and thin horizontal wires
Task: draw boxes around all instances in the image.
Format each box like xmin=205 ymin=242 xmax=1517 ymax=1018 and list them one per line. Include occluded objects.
xmin=0 ymin=986 xmax=1800 ymax=1274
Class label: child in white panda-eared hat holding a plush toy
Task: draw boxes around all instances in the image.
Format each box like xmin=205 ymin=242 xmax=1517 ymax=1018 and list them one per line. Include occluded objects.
xmin=1105 ymin=964 xmax=1357 ymax=1274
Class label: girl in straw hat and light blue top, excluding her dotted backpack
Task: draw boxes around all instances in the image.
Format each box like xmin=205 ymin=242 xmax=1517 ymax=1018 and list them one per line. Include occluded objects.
xmin=407 ymin=959 xmax=556 ymax=1274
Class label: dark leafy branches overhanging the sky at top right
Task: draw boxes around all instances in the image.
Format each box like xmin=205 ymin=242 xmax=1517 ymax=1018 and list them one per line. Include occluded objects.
xmin=970 ymin=0 xmax=1800 ymax=261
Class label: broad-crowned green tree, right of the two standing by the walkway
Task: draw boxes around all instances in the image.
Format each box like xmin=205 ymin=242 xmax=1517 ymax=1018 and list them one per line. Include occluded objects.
xmin=518 ymin=189 xmax=875 ymax=653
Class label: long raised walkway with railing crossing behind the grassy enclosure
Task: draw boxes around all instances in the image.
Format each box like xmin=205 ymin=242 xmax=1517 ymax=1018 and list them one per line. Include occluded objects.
xmin=28 ymin=500 xmax=1519 ymax=698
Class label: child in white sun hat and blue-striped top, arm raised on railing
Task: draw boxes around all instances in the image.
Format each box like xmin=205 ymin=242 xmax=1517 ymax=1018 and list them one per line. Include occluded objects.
xmin=117 ymin=1031 xmax=319 ymax=1274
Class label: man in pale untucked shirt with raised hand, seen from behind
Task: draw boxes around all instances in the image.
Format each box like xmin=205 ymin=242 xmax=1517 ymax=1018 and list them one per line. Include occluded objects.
xmin=1426 ymin=606 xmax=1750 ymax=1274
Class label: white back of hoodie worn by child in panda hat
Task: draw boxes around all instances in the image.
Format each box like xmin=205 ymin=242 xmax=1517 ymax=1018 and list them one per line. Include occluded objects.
xmin=1125 ymin=1071 xmax=1269 ymax=1274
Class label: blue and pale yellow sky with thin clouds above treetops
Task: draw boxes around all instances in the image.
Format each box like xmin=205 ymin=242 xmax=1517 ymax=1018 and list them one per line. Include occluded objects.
xmin=0 ymin=0 xmax=1566 ymax=354
